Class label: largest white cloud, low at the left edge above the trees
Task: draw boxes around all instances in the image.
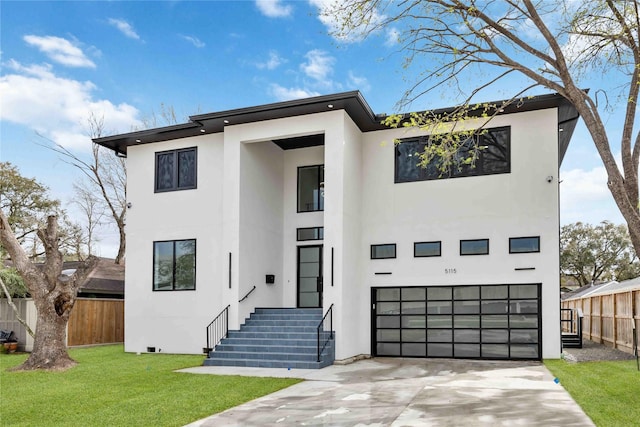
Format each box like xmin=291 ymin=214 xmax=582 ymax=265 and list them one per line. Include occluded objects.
xmin=0 ymin=60 xmax=140 ymax=150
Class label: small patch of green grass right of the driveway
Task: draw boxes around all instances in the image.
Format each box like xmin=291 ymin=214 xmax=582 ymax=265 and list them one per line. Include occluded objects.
xmin=544 ymin=360 xmax=640 ymax=427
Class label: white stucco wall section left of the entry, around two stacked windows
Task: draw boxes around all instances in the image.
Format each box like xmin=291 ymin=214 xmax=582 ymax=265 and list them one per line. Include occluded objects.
xmin=125 ymin=135 xmax=226 ymax=353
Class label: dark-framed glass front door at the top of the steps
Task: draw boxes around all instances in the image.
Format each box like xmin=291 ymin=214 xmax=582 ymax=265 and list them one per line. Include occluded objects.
xmin=298 ymin=245 xmax=322 ymax=308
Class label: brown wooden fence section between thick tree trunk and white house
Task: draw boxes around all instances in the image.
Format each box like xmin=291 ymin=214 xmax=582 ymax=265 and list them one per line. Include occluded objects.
xmin=67 ymin=298 xmax=124 ymax=346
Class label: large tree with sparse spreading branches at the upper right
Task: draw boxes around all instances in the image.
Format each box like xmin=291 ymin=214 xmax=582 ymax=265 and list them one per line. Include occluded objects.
xmin=328 ymin=0 xmax=640 ymax=254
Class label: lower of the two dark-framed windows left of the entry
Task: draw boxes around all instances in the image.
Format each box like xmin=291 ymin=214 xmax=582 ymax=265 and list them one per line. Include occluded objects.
xmin=153 ymin=239 xmax=196 ymax=291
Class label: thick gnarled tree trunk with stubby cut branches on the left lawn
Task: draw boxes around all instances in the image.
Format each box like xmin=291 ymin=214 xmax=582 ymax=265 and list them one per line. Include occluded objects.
xmin=0 ymin=210 xmax=97 ymax=370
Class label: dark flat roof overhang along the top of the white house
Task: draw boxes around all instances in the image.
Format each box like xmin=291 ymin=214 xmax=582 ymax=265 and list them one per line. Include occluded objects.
xmin=93 ymin=91 xmax=579 ymax=163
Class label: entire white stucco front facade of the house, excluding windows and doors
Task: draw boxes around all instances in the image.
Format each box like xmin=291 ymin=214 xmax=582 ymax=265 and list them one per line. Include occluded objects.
xmin=125 ymin=105 xmax=560 ymax=359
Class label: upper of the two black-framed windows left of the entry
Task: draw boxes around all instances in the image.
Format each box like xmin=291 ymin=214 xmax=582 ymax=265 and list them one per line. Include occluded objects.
xmin=155 ymin=147 xmax=198 ymax=193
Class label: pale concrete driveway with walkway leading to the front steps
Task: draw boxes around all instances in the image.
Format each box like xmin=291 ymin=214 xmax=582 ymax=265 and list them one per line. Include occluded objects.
xmin=182 ymin=358 xmax=594 ymax=427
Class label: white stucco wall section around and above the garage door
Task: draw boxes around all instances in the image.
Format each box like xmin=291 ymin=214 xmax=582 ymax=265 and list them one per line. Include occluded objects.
xmin=361 ymin=110 xmax=560 ymax=358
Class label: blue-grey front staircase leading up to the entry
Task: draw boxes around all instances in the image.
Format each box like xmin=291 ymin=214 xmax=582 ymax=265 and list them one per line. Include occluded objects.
xmin=204 ymin=308 xmax=335 ymax=369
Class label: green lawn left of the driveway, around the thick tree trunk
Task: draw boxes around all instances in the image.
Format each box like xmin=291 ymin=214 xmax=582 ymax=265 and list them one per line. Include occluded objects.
xmin=0 ymin=345 xmax=300 ymax=426
